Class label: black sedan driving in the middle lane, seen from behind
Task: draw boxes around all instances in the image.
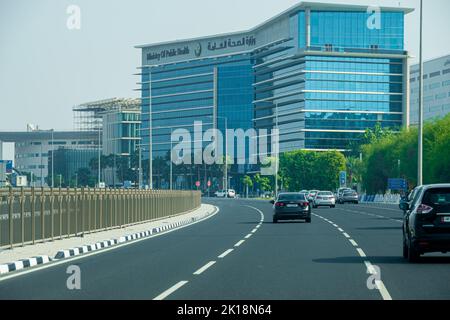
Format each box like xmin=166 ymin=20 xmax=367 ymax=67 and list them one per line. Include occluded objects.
xmin=271 ymin=193 xmax=311 ymax=223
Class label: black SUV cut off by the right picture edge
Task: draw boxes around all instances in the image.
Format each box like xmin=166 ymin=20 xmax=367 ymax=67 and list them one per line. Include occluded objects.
xmin=401 ymin=184 xmax=450 ymax=262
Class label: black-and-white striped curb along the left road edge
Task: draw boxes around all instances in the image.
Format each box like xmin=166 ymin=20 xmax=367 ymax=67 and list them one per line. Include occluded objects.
xmin=0 ymin=207 xmax=217 ymax=275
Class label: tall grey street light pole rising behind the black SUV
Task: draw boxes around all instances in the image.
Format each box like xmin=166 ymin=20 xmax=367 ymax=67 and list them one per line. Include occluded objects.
xmin=417 ymin=0 xmax=424 ymax=186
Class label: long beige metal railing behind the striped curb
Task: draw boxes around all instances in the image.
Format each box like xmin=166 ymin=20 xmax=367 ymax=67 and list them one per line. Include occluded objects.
xmin=0 ymin=188 xmax=201 ymax=248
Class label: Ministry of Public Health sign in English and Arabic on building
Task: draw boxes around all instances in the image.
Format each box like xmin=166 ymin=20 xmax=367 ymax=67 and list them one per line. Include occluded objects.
xmin=147 ymin=36 xmax=256 ymax=61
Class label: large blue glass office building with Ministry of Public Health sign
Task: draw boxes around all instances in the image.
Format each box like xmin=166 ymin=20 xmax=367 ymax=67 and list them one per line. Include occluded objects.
xmin=137 ymin=2 xmax=412 ymax=182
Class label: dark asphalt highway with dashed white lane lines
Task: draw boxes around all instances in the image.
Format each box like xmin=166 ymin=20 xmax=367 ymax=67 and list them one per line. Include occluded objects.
xmin=0 ymin=199 xmax=450 ymax=300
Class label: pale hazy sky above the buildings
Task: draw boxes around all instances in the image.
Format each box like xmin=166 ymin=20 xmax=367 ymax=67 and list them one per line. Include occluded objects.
xmin=0 ymin=0 xmax=450 ymax=131
